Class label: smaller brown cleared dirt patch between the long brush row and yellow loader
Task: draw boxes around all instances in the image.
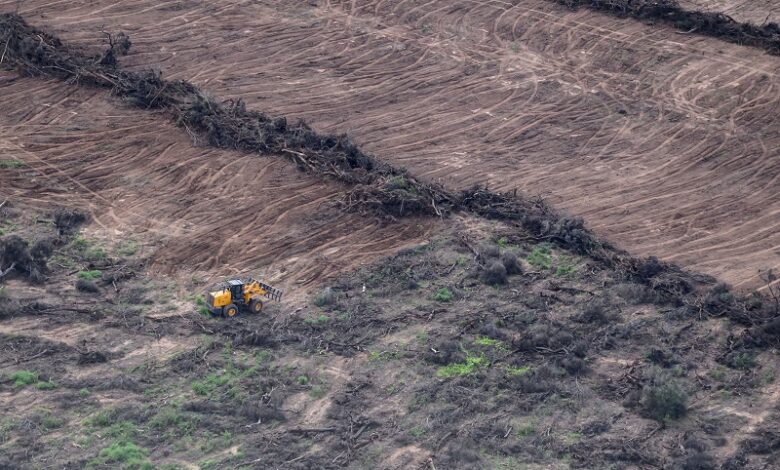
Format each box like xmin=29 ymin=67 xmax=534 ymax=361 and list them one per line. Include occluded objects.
xmin=0 ymin=73 xmax=433 ymax=294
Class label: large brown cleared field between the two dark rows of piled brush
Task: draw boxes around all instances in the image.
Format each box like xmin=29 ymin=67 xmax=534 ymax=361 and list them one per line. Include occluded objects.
xmin=4 ymin=0 xmax=780 ymax=287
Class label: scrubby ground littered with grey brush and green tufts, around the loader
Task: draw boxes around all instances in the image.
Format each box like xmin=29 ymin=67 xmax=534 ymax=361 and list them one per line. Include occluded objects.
xmin=0 ymin=207 xmax=780 ymax=469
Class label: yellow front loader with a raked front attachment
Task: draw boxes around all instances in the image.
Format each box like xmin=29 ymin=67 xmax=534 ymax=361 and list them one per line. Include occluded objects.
xmin=206 ymin=277 xmax=282 ymax=317
